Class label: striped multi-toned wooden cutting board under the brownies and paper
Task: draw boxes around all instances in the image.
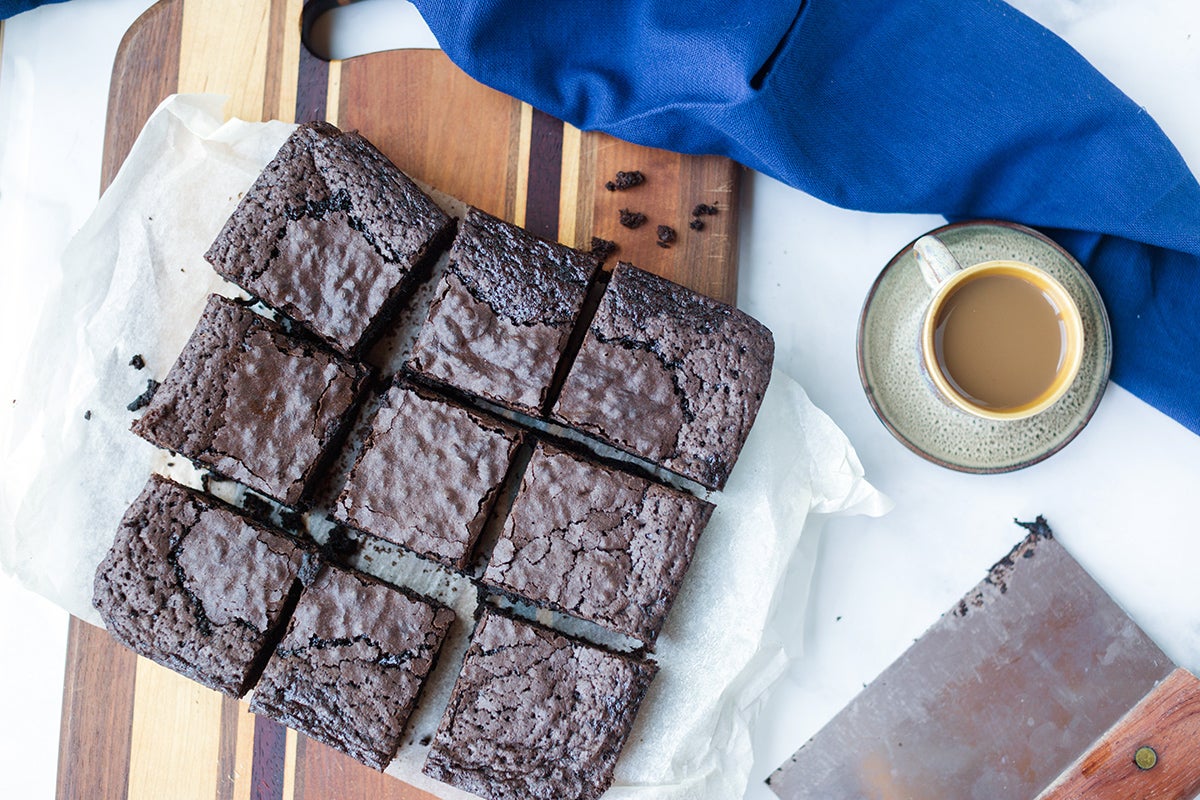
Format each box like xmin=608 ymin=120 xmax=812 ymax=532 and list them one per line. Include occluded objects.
xmin=58 ymin=0 xmax=740 ymax=800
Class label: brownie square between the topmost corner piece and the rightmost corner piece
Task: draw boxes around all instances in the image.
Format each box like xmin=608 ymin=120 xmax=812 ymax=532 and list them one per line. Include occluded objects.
xmin=407 ymin=209 xmax=600 ymax=416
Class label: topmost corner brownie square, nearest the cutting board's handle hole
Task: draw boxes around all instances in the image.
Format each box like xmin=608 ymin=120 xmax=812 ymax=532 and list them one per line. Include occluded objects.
xmin=205 ymin=122 xmax=454 ymax=357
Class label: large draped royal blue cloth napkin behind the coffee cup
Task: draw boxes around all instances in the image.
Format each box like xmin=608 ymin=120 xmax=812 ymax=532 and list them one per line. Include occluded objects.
xmin=415 ymin=0 xmax=1200 ymax=433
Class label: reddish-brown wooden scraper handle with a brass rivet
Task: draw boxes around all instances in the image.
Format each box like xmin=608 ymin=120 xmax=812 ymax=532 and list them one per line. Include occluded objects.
xmin=1037 ymin=669 xmax=1200 ymax=800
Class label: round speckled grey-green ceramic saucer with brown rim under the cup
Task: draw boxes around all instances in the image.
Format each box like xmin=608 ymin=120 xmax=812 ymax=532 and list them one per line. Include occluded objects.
xmin=858 ymin=221 xmax=1112 ymax=473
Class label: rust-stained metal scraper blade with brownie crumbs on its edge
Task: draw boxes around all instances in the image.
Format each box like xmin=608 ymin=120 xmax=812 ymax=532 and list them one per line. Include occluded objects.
xmin=768 ymin=517 xmax=1174 ymax=800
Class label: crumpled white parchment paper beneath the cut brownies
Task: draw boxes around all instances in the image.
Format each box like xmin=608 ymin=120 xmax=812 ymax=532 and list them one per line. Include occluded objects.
xmin=0 ymin=96 xmax=889 ymax=800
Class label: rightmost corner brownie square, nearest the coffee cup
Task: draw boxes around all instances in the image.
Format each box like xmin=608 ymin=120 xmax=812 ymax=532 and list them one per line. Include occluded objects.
xmin=553 ymin=263 xmax=775 ymax=489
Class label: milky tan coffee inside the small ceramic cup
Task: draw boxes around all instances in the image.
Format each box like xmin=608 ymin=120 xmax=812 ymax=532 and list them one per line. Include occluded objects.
xmin=934 ymin=272 xmax=1068 ymax=410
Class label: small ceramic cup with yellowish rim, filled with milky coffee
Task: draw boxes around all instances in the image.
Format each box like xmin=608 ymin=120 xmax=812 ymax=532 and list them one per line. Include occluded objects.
xmin=913 ymin=236 xmax=1084 ymax=420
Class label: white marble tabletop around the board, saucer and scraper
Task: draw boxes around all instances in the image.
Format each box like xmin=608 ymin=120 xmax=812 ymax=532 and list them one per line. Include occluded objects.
xmin=0 ymin=0 xmax=1200 ymax=800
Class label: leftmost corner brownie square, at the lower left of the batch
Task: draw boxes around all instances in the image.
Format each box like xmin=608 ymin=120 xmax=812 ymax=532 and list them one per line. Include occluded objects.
xmin=92 ymin=475 xmax=307 ymax=697
